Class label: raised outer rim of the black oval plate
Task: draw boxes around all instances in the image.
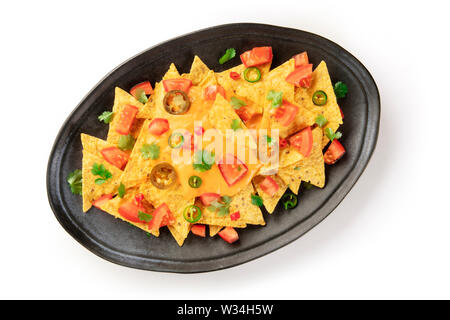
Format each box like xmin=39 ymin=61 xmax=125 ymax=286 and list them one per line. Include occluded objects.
xmin=46 ymin=23 xmax=381 ymax=273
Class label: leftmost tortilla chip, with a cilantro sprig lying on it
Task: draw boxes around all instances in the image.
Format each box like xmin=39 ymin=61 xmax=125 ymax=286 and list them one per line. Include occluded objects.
xmin=82 ymin=150 xmax=122 ymax=212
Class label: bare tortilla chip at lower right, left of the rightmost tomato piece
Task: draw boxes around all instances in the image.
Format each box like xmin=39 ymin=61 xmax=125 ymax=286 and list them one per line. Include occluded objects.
xmin=278 ymin=127 xmax=325 ymax=192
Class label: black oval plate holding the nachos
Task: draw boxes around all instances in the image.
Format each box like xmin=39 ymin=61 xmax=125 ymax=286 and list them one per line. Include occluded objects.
xmin=47 ymin=23 xmax=380 ymax=273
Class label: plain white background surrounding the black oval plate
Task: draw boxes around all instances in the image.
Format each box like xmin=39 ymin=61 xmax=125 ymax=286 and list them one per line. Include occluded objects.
xmin=0 ymin=0 xmax=450 ymax=300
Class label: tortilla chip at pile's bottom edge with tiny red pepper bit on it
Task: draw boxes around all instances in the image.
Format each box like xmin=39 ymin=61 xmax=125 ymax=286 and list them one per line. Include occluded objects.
xmin=198 ymin=184 xmax=266 ymax=228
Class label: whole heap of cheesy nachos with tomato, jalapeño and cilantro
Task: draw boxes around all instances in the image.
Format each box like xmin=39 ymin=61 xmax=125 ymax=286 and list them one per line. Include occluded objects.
xmin=68 ymin=47 xmax=347 ymax=246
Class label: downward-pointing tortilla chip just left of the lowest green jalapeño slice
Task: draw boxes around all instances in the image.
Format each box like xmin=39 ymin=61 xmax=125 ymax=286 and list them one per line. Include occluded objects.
xmin=139 ymin=181 xmax=194 ymax=247
